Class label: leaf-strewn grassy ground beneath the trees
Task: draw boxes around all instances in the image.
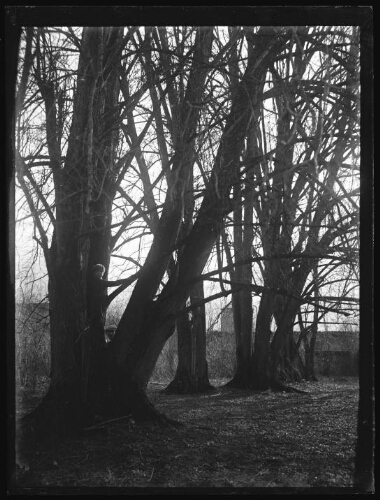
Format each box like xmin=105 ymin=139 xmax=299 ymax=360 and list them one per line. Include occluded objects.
xmin=9 ymin=378 xmax=358 ymax=493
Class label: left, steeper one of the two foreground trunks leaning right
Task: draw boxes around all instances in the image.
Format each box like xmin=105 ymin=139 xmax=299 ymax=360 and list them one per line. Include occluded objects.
xmin=103 ymin=24 xmax=217 ymax=419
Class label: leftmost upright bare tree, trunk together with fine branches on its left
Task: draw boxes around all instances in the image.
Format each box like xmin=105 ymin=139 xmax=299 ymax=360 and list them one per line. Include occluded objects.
xmin=16 ymin=28 xmax=141 ymax=432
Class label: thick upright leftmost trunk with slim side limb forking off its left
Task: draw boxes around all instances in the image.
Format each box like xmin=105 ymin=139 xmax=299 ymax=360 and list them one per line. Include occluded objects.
xmin=18 ymin=28 xmax=122 ymax=440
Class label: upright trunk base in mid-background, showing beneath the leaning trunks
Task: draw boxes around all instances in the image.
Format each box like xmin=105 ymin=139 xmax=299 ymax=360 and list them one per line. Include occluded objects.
xmin=165 ymin=281 xmax=213 ymax=394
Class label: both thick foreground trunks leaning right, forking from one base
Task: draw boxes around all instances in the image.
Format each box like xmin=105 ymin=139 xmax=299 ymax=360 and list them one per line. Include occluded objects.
xmin=103 ymin=29 xmax=283 ymax=418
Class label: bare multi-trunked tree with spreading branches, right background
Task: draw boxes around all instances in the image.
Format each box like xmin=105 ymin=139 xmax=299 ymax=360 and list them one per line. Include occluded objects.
xmin=215 ymin=28 xmax=358 ymax=388
